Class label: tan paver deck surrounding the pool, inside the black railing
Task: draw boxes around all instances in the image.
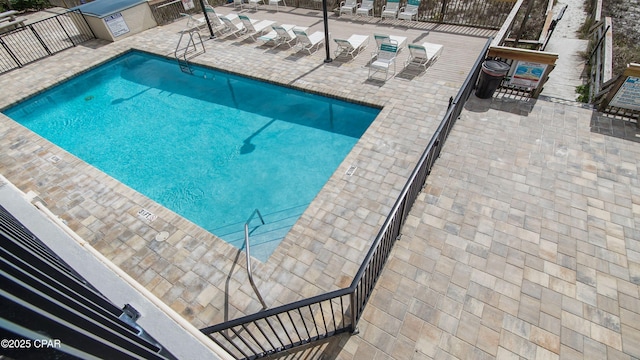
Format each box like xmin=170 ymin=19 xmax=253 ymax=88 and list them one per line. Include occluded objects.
xmin=0 ymin=6 xmax=493 ymax=327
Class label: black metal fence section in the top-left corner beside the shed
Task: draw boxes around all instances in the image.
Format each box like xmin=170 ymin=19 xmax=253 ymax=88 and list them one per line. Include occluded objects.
xmin=0 ymin=10 xmax=95 ymax=74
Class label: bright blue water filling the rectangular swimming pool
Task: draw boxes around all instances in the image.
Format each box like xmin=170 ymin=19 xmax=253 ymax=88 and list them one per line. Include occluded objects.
xmin=3 ymin=52 xmax=379 ymax=260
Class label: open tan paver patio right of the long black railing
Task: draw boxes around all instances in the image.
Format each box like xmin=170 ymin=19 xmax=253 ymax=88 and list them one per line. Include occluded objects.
xmin=333 ymin=96 xmax=640 ymax=359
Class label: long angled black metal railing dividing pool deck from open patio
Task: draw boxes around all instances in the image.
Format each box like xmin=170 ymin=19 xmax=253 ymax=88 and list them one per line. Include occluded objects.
xmin=201 ymin=39 xmax=492 ymax=359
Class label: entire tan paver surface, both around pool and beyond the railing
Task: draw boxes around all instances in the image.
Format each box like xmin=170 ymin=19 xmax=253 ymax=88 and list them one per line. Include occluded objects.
xmin=0 ymin=7 xmax=640 ymax=359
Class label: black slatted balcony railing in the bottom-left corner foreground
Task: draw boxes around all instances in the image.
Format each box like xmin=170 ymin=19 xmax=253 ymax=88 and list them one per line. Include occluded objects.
xmin=0 ymin=206 xmax=175 ymax=359
